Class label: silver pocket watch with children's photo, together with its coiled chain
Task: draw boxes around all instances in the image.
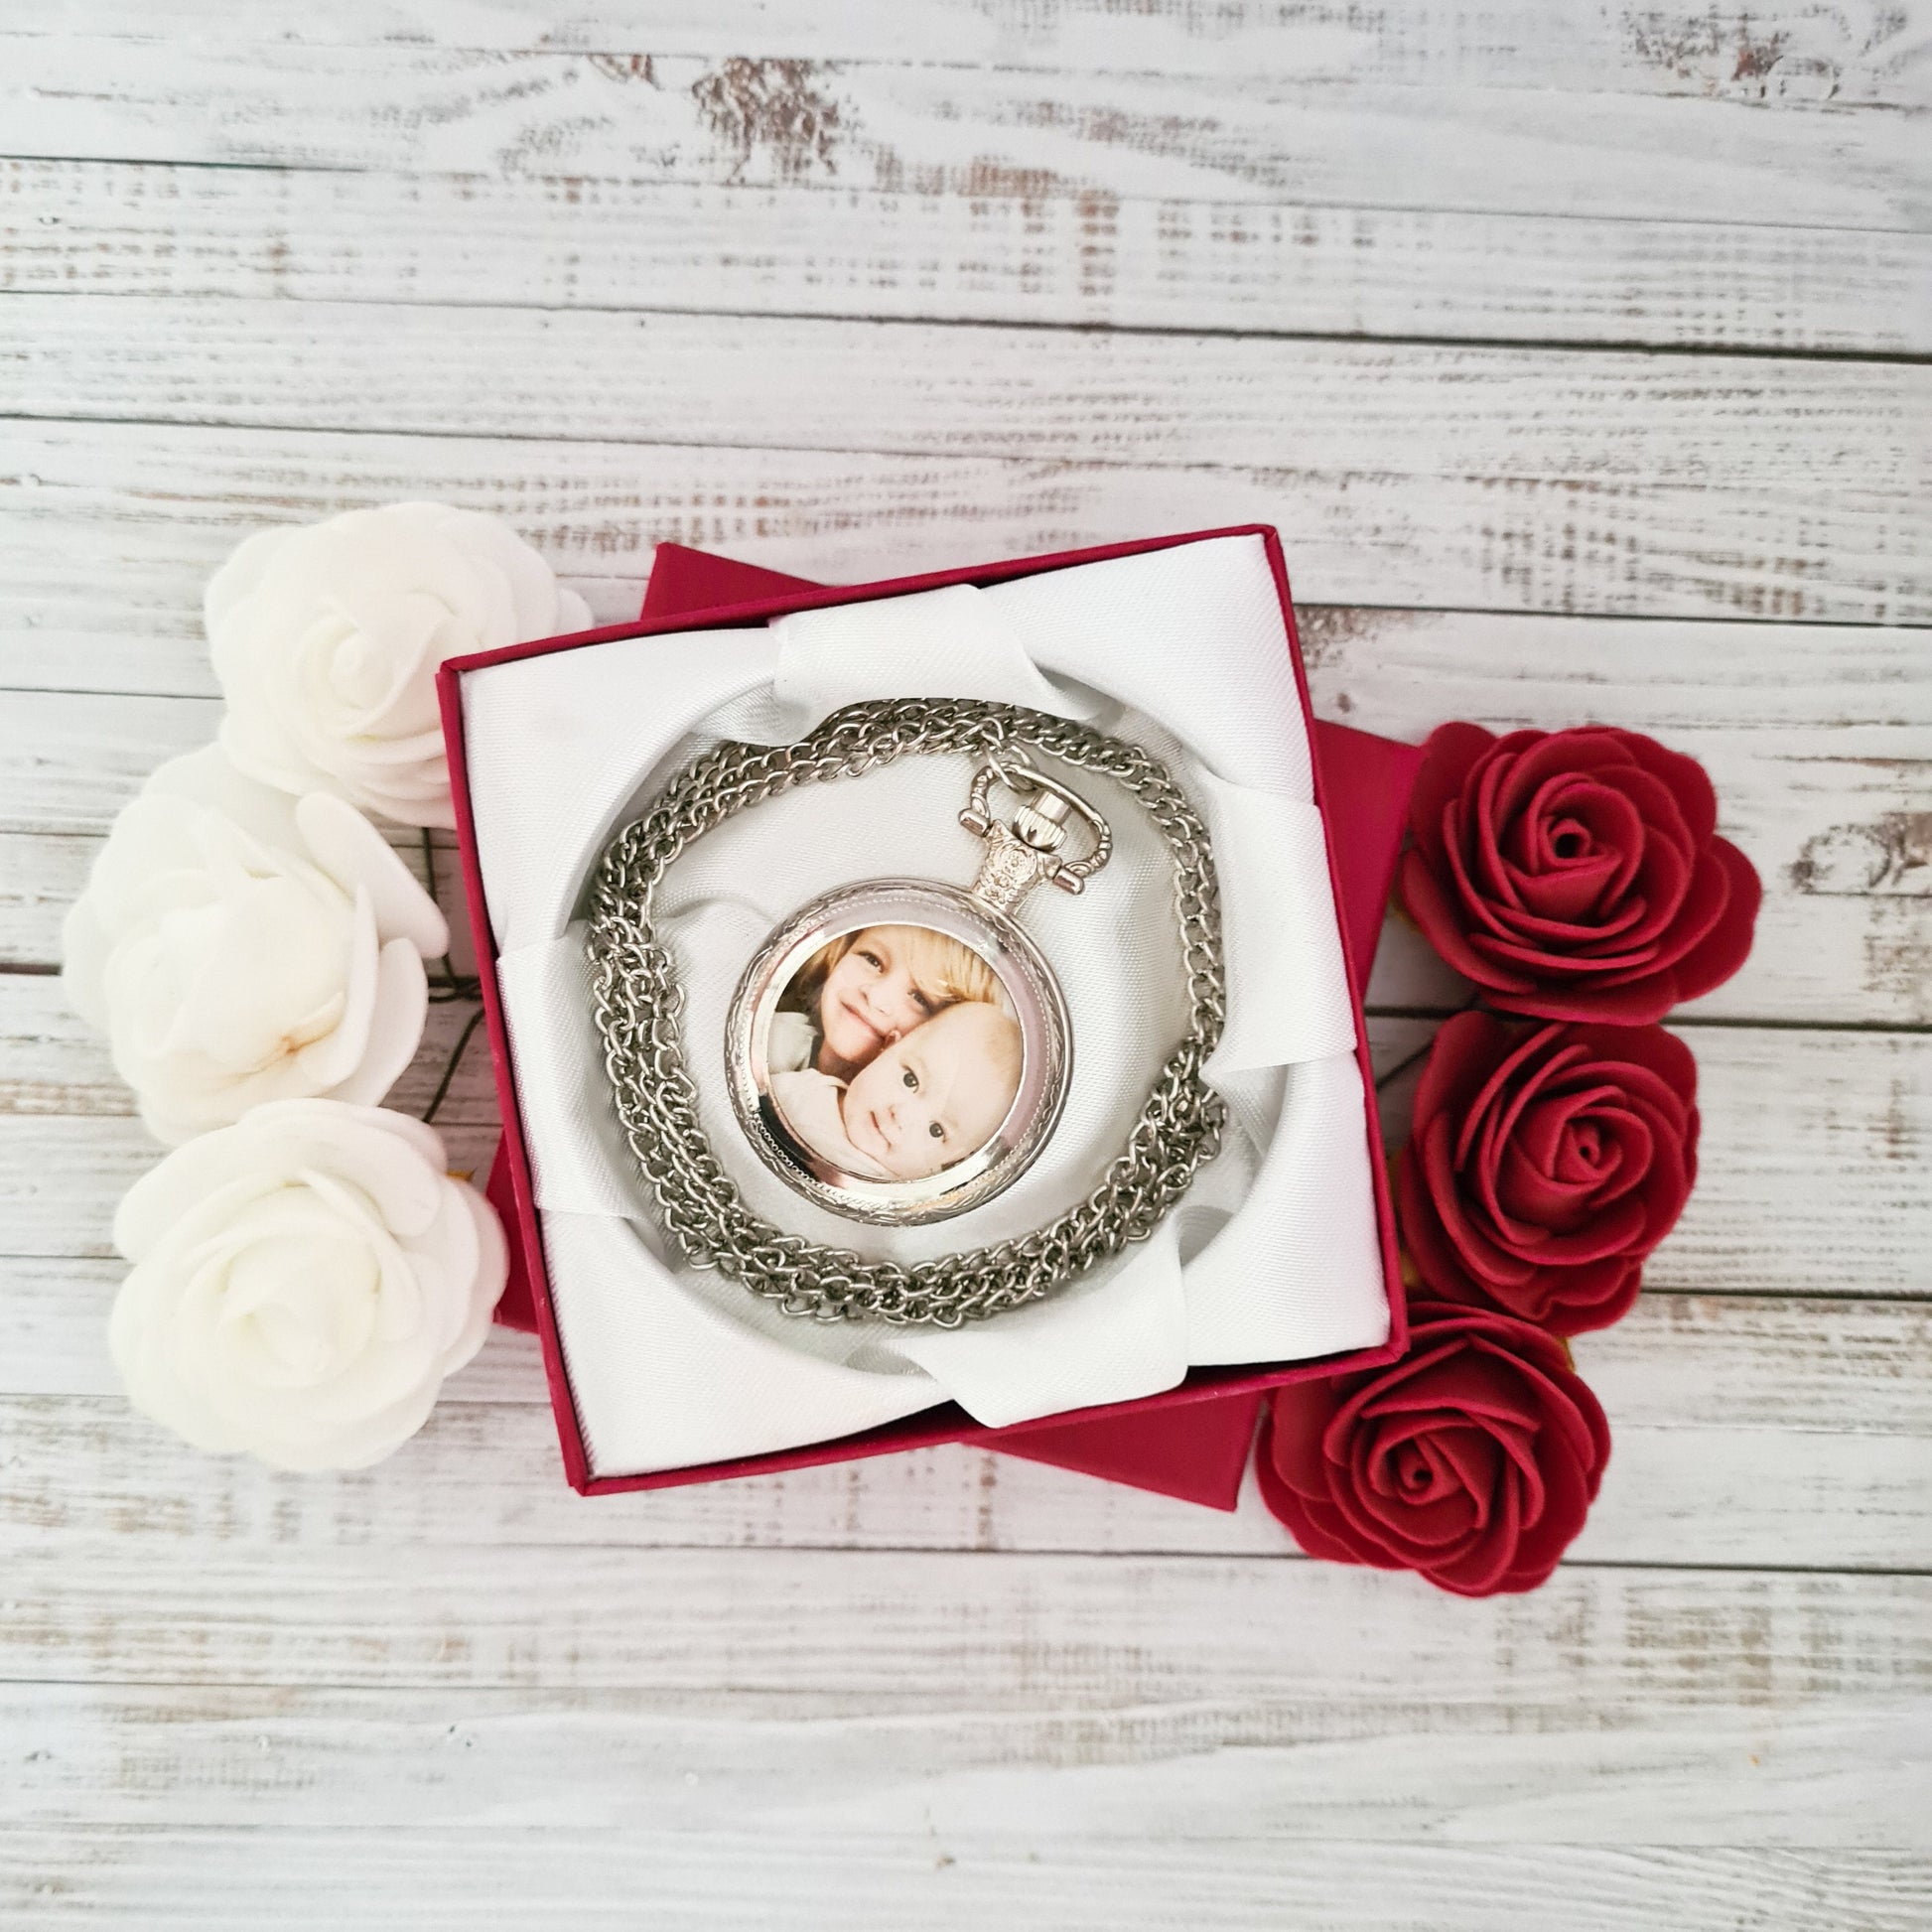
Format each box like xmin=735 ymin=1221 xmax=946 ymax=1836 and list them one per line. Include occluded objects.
xmin=586 ymin=698 xmax=1227 ymax=1327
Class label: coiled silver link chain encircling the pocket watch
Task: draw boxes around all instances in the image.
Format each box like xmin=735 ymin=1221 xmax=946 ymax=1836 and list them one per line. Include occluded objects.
xmin=588 ymin=699 xmax=1227 ymax=1327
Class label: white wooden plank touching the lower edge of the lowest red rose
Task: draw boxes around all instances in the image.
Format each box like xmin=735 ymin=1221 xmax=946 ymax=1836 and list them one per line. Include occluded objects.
xmin=0 ymin=1522 xmax=1932 ymax=1692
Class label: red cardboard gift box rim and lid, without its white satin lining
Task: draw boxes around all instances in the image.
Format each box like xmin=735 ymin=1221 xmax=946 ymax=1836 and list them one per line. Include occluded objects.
xmin=437 ymin=525 xmax=1420 ymax=1509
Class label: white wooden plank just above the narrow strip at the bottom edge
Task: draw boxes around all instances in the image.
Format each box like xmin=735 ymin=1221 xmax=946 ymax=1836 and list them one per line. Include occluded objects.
xmin=0 ymin=1685 xmax=1932 ymax=1855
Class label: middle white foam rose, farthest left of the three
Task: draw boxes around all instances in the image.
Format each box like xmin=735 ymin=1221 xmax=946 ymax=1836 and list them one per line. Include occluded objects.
xmin=62 ymin=746 xmax=450 ymax=1146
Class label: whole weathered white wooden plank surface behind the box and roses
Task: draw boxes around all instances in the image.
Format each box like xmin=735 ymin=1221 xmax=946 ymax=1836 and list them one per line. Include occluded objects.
xmin=0 ymin=0 xmax=1932 ymax=1932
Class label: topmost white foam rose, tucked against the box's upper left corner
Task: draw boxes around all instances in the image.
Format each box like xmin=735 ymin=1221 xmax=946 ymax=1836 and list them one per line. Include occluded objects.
xmin=205 ymin=502 xmax=591 ymax=825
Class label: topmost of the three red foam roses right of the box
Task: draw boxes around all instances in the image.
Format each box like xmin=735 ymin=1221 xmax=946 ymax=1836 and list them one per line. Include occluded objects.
xmin=1397 ymin=725 xmax=1762 ymax=1026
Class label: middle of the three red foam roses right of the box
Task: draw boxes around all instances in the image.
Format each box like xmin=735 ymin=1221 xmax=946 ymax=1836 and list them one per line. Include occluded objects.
xmin=1397 ymin=1013 xmax=1699 ymax=1335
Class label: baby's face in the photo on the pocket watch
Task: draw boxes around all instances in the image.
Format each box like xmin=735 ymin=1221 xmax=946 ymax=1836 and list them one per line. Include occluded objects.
xmin=841 ymin=999 xmax=1020 ymax=1180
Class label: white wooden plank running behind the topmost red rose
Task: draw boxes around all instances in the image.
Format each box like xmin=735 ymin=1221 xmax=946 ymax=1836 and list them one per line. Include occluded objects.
xmin=0 ymin=603 xmax=1932 ymax=1024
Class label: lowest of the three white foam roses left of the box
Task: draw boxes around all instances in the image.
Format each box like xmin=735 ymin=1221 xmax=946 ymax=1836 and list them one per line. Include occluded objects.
xmin=108 ymin=1099 xmax=506 ymax=1470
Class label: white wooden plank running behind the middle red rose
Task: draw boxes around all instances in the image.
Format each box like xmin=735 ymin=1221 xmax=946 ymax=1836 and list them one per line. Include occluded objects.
xmin=0 ymin=1026 xmax=1932 ymax=1297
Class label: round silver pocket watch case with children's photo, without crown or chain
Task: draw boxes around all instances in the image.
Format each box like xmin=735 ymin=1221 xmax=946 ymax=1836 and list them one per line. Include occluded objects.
xmin=725 ymin=879 xmax=1072 ymax=1227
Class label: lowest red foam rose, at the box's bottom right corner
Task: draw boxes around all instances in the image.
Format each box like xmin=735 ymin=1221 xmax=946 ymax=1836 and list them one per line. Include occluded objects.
xmin=1258 ymin=1303 xmax=1609 ymax=1595
